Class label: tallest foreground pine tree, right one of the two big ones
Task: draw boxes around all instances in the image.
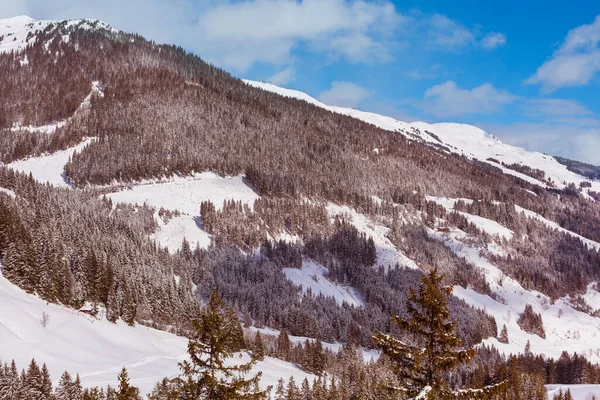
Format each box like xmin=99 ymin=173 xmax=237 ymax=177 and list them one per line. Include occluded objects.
xmin=374 ymin=269 xmax=504 ymax=399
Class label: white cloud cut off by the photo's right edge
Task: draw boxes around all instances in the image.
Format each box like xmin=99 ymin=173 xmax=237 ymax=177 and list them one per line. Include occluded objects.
xmin=525 ymin=15 xmax=600 ymax=92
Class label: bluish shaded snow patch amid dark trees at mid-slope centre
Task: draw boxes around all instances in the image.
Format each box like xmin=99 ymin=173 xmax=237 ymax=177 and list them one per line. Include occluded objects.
xmin=283 ymin=260 xmax=365 ymax=307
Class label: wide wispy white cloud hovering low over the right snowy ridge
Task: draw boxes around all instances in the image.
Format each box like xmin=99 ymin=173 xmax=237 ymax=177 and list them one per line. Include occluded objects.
xmin=419 ymin=81 xmax=518 ymax=117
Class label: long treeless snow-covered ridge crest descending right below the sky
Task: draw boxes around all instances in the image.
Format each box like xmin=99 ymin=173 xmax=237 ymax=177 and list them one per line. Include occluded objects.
xmin=244 ymin=80 xmax=600 ymax=191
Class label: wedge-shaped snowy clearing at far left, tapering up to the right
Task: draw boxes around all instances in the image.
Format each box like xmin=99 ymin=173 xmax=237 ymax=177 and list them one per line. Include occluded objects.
xmin=7 ymin=138 xmax=95 ymax=187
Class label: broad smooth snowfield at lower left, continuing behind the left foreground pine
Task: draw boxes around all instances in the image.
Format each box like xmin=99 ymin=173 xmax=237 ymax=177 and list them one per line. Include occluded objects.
xmin=0 ymin=274 xmax=314 ymax=395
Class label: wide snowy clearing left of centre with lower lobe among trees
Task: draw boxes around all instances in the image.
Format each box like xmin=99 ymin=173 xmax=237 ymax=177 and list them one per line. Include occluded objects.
xmin=106 ymin=172 xmax=259 ymax=252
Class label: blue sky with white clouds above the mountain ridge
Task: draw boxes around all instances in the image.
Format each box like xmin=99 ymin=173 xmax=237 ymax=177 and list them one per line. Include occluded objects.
xmin=0 ymin=0 xmax=600 ymax=164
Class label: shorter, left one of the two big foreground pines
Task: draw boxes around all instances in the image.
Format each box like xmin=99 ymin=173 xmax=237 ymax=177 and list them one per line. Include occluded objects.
xmin=179 ymin=291 xmax=267 ymax=400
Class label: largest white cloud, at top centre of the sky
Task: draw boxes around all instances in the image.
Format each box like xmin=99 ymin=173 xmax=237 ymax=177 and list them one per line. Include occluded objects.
xmin=186 ymin=0 xmax=402 ymax=71
